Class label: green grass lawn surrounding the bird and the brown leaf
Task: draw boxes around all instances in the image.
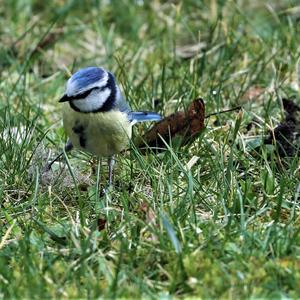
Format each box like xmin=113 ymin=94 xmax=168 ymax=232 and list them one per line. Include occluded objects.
xmin=0 ymin=0 xmax=300 ymax=299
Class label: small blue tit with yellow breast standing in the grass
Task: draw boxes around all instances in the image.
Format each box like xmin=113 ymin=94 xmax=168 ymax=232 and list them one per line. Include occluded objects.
xmin=49 ymin=67 xmax=162 ymax=186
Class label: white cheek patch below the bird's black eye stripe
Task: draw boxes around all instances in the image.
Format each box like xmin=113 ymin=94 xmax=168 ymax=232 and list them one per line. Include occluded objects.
xmin=72 ymin=88 xmax=111 ymax=112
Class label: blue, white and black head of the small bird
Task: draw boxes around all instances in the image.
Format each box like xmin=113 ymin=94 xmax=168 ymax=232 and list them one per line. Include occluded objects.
xmin=59 ymin=67 xmax=121 ymax=113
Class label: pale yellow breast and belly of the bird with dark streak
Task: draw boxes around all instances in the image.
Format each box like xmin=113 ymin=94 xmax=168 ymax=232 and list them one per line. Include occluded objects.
xmin=63 ymin=103 xmax=131 ymax=156
